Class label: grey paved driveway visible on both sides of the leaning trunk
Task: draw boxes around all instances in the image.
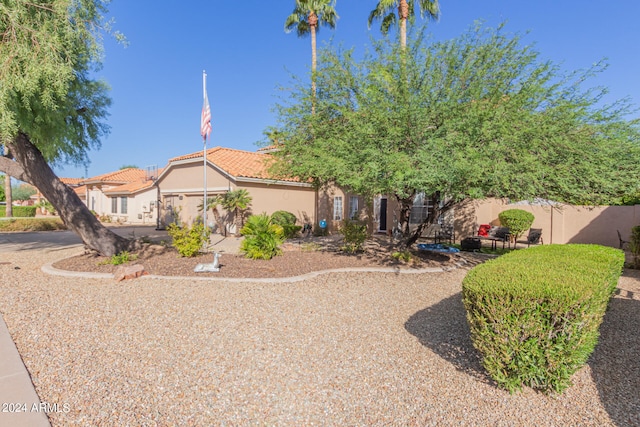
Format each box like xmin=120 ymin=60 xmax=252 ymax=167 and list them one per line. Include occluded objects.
xmin=0 ymin=225 xmax=169 ymax=253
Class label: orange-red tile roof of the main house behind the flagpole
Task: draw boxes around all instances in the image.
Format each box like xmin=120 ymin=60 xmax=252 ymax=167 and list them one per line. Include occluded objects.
xmin=169 ymin=147 xmax=298 ymax=182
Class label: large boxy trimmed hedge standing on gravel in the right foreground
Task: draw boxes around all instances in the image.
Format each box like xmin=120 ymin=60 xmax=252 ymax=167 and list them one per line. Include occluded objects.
xmin=462 ymin=245 xmax=624 ymax=392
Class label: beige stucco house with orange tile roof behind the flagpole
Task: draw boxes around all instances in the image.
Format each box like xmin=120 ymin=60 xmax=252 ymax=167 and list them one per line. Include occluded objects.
xmin=156 ymin=147 xmax=364 ymax=231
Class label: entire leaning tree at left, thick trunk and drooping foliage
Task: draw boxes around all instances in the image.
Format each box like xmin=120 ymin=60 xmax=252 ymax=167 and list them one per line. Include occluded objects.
xmin=0 ymin=0 xmax=132 ymax=256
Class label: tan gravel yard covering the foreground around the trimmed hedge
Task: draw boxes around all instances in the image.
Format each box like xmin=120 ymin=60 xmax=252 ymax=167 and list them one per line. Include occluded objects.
xmin=0 ymin=249 xmax=640 ymax=426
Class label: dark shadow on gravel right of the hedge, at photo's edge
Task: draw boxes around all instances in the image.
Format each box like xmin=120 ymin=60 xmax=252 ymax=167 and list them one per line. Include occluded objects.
xmin=588 ymin=280 xmax=640 ymax=426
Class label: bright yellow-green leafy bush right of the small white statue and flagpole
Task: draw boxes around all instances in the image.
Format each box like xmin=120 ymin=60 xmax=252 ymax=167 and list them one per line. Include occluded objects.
xmin=240 ymin=213 xmax=285 ymax=259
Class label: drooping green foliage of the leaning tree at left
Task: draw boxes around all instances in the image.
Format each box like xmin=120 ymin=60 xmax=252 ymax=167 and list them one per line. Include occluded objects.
xmin=0 ymin=0 xmax=110 ymax=171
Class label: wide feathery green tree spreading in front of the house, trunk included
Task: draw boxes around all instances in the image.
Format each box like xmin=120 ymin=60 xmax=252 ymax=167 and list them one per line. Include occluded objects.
xmin=274 ymin=25 xmax=640 ymax=245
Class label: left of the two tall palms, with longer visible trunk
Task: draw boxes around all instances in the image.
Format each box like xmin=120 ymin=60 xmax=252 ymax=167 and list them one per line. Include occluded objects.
xmin=284 ymin=0 xmax=339 ymax=102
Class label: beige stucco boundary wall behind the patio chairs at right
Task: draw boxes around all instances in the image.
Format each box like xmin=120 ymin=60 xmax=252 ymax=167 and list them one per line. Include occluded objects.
xmin=456 ymin=199 xmax=640 ymax=247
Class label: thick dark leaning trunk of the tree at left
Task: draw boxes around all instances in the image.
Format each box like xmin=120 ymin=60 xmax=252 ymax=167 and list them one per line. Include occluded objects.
xmin=9 ymin=133 xmax=135 ymax=256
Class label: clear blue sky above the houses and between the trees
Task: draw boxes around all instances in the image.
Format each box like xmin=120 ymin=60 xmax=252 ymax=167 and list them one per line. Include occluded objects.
xmin=54 ymin=0 xmax=640 ymax=177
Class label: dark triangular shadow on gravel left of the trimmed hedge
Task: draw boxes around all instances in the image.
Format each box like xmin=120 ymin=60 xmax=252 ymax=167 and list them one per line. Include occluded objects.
xmin=404 ymin=292 xmax=494 ymax=384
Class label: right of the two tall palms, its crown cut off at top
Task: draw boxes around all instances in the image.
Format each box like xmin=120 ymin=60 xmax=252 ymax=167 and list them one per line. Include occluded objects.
xmin=369 ymin=0 xmax=440 ymax=49
